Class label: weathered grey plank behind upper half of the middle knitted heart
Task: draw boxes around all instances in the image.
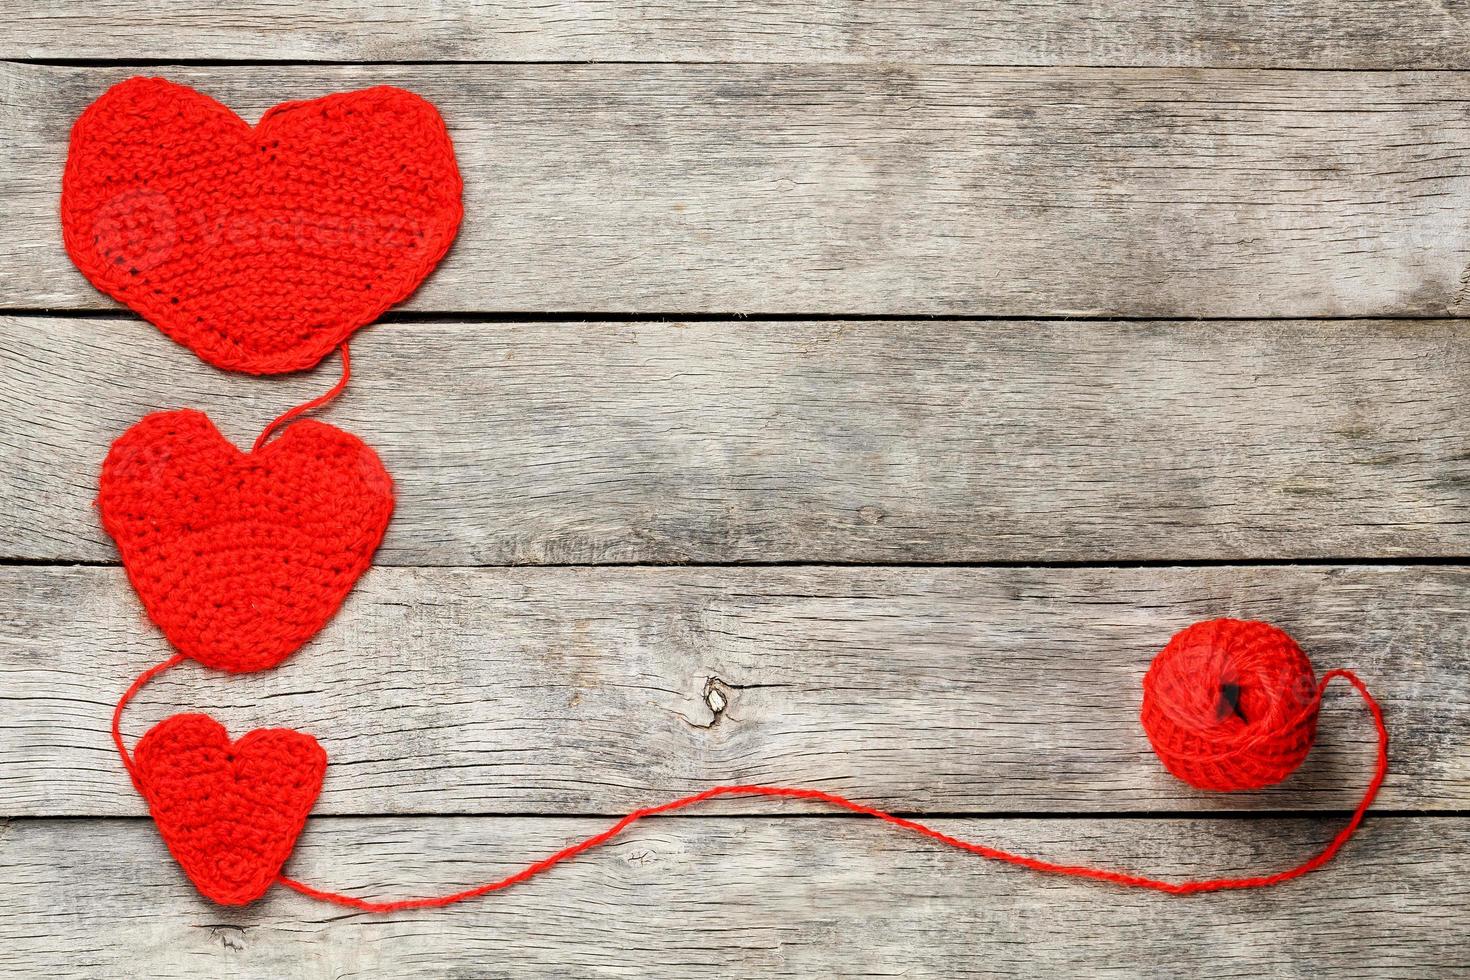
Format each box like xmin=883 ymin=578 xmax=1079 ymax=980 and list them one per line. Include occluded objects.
xmin=0 ymin=317 xmax=1470 ymax=566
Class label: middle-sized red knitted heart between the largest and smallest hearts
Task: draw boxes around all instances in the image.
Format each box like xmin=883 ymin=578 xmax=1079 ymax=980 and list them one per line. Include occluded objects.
xmin=97 ymin=408 xmax=392 ymax=671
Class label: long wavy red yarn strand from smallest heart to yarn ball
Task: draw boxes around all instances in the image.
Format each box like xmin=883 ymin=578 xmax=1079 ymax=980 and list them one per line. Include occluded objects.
xmin=276 ymin=670 xmax=1388 ymax=912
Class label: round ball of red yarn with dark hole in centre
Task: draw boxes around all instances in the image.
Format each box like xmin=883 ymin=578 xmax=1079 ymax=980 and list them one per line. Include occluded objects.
xmin=1141 ymin=619 xmax=1320 ymax=790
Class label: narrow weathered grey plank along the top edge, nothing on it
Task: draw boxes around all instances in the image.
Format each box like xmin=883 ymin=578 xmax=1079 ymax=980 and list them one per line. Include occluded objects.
xmin=0 ymin=0 xmax=1470 ymax=68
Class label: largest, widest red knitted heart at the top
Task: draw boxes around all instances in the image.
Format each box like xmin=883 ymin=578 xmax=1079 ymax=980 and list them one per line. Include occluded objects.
xmin=62 ymin=78 xmax=463 ymax=375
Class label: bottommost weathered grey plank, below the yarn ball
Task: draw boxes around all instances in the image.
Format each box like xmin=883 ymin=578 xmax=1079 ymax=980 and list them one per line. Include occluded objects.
xmin=0 ymin=817 xmax=1470 ymax=980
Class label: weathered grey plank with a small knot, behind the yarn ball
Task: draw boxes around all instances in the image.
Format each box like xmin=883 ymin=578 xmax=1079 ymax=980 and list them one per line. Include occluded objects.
xmin=0 ymin=567 xmax=1470 ymax=815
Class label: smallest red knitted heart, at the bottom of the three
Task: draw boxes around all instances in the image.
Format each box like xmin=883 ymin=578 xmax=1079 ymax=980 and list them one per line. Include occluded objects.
xmin=134 ymin=714 xmax=326 ymax=905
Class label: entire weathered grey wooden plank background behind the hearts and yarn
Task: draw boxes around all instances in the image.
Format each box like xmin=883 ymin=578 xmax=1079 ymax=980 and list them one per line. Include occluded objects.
xmin=0 ymin=0 xmax=1470 ymax=980
